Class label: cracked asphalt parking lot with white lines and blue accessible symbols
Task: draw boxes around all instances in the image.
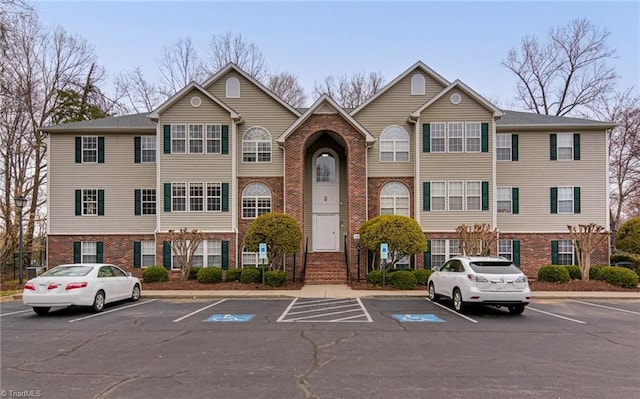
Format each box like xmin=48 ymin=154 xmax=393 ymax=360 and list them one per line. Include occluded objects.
xmin=0 ymin=297 xmax=640 ymax=399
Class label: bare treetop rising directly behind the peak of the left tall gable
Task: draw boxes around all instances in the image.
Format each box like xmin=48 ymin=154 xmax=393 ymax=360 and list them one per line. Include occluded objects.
xmin=205 ymin=32 xmax=268 ymax=82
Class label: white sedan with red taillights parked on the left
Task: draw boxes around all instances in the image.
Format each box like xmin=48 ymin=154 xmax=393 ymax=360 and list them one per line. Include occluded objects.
xmin=22 ymin=263 xmax=142 ymax=316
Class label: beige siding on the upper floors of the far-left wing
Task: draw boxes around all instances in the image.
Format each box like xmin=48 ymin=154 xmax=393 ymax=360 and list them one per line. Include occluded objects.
xmin=48 ymin=132 xmax=159 ymax=234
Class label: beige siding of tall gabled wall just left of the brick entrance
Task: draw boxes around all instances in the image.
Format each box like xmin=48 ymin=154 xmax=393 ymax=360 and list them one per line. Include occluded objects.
xmin=207 ymin=71 xmax=297 ymax=177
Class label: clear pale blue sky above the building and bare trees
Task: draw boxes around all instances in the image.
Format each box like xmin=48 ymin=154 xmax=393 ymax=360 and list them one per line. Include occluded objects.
xmin=36 ymin=1 xmax=640 ymax=106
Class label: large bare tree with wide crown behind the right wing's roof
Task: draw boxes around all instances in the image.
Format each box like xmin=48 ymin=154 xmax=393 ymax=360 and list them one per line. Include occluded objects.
xmin=502 ymin=19 xmax=617 ymax=116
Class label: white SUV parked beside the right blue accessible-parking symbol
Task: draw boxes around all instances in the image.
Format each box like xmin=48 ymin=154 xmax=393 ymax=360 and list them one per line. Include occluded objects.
xmin=428 ymin=256 xmax=531 ymax=314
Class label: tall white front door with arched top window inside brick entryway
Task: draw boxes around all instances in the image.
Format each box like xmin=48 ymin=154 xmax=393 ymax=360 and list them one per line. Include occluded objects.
xmin=313 ymin=150 xmax=340 ymax=252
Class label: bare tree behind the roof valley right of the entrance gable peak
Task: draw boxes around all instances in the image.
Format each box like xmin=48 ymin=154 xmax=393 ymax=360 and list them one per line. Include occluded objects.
xmin=314 ymin=72 xmax=384 ymax=108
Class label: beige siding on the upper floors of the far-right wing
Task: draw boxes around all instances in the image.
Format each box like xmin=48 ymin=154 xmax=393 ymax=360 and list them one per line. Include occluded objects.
xmin=497 ymin=131 xmax=607 ymax=232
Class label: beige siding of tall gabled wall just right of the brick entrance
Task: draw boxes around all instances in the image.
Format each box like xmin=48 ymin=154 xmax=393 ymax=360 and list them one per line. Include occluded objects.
xmin=354 ymin=72 xmax=444 ymax=177
